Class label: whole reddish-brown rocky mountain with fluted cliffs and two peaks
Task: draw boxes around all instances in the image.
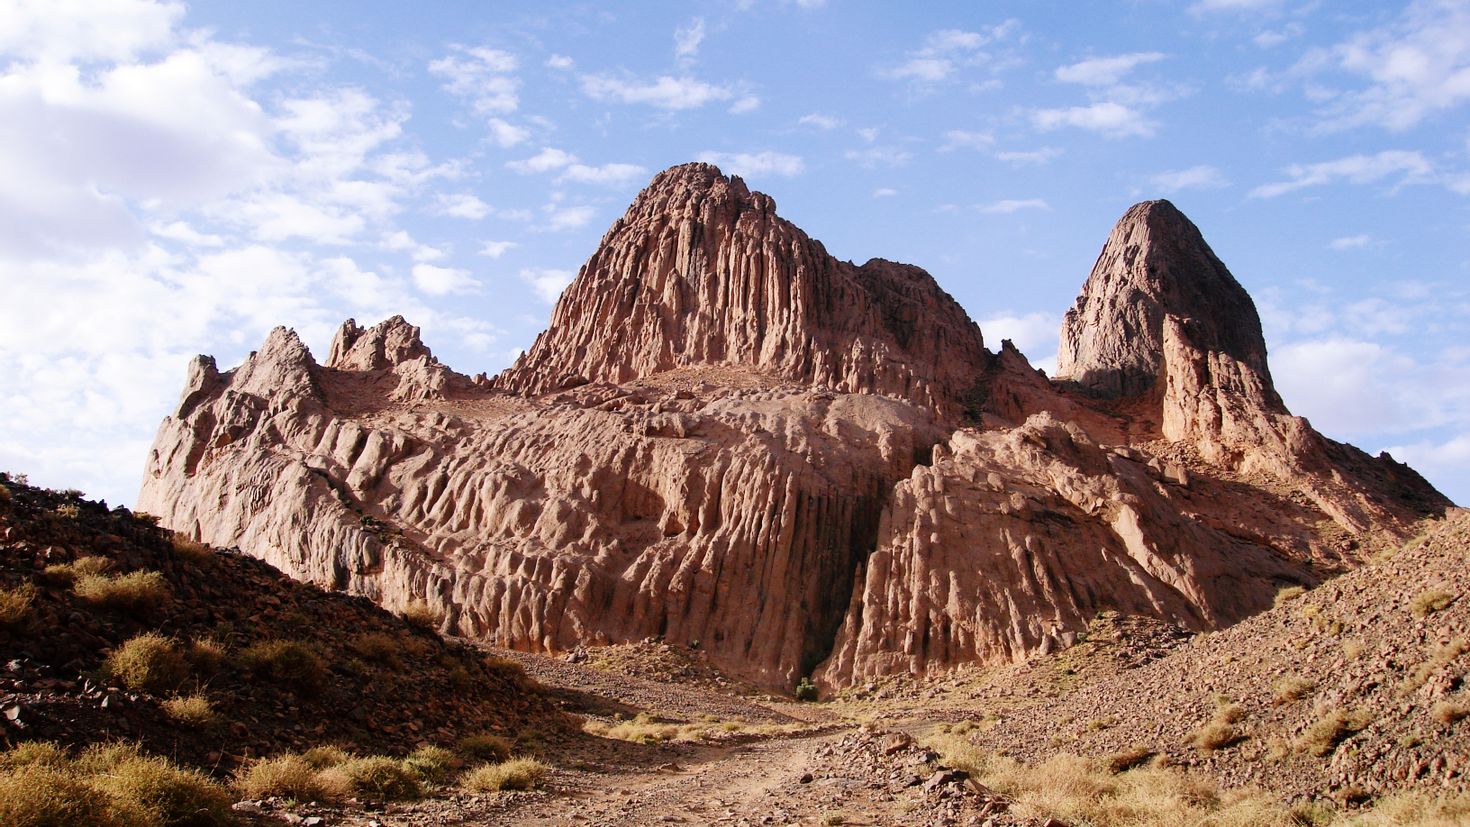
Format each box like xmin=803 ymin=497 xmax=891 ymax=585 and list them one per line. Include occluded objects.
xmin=140 ymin=165 xmax=1448 ymax=687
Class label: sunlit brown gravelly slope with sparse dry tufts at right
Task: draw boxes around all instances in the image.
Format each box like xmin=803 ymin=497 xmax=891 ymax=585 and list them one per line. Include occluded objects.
xmin=973 ymin=510 xmax=1470 ymax=802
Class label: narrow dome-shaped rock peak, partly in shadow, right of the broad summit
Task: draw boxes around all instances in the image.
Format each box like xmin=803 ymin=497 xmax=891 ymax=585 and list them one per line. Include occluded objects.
xmin=1057 ymin=200 xmax=1274 ymax=397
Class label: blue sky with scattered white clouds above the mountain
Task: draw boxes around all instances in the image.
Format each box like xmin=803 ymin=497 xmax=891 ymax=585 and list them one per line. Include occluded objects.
xmin=0 ymin=0 xmax=1470 ymax=502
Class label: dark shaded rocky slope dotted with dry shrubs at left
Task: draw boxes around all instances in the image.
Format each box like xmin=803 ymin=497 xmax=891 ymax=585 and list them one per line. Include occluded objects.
xmin=0 ymin=474 xmax=575 ymax=771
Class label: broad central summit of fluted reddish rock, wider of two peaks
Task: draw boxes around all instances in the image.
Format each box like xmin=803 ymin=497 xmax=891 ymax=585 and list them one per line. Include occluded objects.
xmin=495 ymin=163 xmax=988 ymax=414
